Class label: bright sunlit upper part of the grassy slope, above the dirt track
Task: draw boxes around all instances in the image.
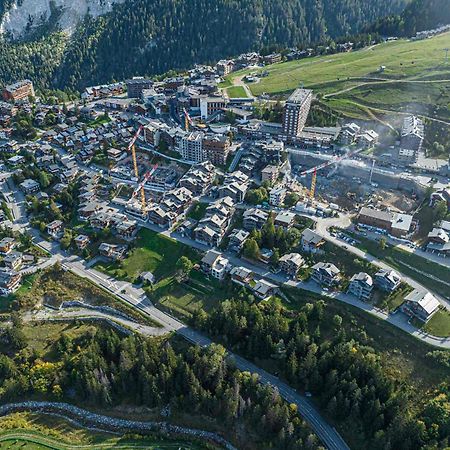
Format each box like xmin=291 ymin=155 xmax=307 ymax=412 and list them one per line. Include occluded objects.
xmin=228 ymin=33 xmax=450 ymax=95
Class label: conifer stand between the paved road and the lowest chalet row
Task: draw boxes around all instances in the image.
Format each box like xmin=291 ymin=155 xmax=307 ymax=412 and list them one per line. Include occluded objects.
xmin=193 ymin=295 xmax=450 ymax=450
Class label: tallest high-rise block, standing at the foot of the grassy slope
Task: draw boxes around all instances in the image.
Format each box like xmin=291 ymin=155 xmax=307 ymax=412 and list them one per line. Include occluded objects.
xmin=282 ymin=89 xmax=312 ymax=136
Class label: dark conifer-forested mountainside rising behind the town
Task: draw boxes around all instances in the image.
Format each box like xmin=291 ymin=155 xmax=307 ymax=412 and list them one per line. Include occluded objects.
xmin=0 ymin=0 xmax=406 ymax=89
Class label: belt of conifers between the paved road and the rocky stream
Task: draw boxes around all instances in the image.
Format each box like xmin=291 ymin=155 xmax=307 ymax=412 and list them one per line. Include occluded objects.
xmin=0 ymin=315 xmax=323 ymax=450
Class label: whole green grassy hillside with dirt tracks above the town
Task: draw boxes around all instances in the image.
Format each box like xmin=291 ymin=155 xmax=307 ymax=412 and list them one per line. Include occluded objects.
xmin=228 ymin=33 xmax=450 ymax=123
